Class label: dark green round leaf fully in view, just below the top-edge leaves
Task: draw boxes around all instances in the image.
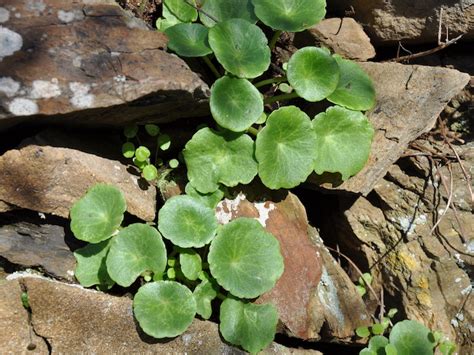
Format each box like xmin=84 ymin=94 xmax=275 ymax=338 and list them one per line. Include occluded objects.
xmin=209 ymin=19 xmax=270 ymax=78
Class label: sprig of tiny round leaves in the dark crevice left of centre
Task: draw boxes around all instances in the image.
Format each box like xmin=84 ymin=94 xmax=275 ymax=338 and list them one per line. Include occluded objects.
xmin=122 ymin=124 xmax=179 ymax=181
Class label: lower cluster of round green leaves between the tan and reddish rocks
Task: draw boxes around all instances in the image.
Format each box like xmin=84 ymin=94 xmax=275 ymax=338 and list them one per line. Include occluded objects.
xmin=70 ymin=185 xmax=283 ymax=353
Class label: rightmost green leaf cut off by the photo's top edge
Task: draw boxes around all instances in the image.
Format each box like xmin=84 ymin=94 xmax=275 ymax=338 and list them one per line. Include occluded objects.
xmin=252 ymin=0 xmax=326 ymax=32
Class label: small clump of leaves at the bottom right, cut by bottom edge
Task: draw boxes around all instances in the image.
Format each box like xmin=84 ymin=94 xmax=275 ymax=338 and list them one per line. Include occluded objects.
xmin=356 ymin=318 xmax=456 ymax=355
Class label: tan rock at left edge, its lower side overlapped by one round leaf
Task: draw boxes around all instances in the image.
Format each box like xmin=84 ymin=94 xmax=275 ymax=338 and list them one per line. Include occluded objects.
xmin=0 ymin=129 xmax=156 ymax=221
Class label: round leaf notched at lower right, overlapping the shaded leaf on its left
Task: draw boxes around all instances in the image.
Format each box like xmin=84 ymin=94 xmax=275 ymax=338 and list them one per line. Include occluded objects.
xmin=106 ymin=223 xmax=166 ymax=287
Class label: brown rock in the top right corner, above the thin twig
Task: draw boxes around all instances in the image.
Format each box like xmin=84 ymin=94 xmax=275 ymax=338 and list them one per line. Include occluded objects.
xmin=328 ymin=0 xmax=474 ymax=44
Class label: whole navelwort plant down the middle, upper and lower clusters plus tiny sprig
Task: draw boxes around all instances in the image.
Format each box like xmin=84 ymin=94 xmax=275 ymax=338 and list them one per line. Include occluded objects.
xmin=71 ymin=0 xmax=375 ymax=353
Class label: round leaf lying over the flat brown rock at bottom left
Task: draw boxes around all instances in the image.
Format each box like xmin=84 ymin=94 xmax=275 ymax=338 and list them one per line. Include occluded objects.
xmin=133 ymin=281 xmax=196 ymax=338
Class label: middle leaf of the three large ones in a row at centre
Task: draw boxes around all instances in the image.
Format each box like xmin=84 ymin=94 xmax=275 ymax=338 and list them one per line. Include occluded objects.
xmin=256 ymin=106 xmax=316 ymax=189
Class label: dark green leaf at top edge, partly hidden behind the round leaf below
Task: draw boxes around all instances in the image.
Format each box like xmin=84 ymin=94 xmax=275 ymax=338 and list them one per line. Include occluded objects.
xmin=199 ymin=0 xmax=258 ymax=27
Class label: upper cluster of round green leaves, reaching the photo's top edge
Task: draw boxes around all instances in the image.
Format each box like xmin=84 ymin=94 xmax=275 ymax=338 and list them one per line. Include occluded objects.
xmin=157 ymin=0 xmax=375 ymax=193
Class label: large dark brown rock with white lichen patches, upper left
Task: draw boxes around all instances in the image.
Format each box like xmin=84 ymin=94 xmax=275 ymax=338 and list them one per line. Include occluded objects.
xmin=0 ymin=0 xmax=209 ymax=129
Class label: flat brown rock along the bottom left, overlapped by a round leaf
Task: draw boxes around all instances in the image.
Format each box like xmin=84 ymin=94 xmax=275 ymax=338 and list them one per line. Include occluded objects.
xmin=5 ymin=274 xmax=320 ymax=355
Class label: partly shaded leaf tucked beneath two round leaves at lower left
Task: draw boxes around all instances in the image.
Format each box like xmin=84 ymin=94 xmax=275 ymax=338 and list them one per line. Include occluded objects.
xmin=74 ymin=239 xmax=114 ymax=288
